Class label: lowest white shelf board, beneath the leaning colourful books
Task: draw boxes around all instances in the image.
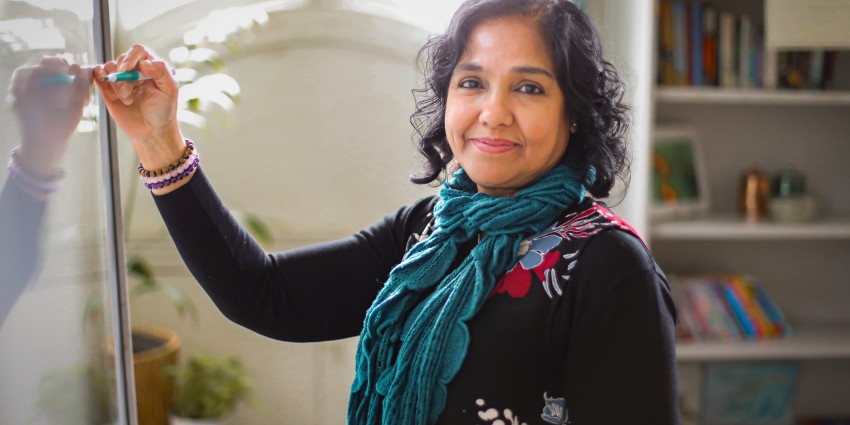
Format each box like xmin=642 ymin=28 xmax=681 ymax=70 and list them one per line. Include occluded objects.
xmin=676 ymin=325 xmax=850 ymax=362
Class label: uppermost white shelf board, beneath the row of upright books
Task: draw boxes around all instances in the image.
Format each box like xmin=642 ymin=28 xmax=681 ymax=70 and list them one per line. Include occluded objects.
xmin=655 ymin=87 xmax=850 ymax=106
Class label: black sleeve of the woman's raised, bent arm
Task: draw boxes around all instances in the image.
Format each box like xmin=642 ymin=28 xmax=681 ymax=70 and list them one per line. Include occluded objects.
xmin=154 ymin=168 xmax=438 ymax=342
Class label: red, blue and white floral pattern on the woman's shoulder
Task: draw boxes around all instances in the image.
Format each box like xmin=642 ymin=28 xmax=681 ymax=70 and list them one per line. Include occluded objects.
xmin=490 ymin=202 xmax=640 ymax=299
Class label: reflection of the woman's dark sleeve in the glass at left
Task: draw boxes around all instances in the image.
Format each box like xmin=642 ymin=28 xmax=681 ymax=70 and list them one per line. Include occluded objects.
xmin=0 ymin=178 xmax=45 ymax=326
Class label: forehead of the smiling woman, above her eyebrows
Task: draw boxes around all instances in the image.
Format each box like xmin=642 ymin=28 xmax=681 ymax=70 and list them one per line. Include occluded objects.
xmin=459 ymin=16 xmax=553 ymax=70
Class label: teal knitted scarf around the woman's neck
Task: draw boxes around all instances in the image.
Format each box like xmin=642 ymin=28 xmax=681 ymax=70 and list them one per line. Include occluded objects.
xmin=348 ymin=165 xmax=584 ymax=425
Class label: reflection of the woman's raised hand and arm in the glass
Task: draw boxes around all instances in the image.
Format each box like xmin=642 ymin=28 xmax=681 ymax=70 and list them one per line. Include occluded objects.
xmin=0 ymin=57 xmax=92 ymax=325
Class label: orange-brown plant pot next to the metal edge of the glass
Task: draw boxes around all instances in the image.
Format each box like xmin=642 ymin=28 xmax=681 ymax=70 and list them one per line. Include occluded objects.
xmin=132 ymin=326 xmax=180 ymax=425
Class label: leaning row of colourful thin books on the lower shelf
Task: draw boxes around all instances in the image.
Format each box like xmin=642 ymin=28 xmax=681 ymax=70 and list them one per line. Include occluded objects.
xmin=669 ymin=275 xmax=792 ymax=341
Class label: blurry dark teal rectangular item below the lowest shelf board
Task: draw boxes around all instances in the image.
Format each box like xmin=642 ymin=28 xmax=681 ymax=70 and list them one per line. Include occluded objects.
xmin=700 ymin=362 xmax=800 ymax=425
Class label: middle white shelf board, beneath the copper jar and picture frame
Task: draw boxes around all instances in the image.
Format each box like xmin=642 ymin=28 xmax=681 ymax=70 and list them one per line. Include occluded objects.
xmin=650 ymin=215 xmax=850 ymax=241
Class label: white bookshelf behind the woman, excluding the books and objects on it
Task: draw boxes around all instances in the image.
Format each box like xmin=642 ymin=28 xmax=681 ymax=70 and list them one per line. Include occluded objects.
xmin=648 ymin=0 xmax=850 ymax=425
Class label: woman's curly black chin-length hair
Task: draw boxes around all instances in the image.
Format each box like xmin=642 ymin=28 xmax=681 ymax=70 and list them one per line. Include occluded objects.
xmin=410 ymin=0 xmax=630 ymax=198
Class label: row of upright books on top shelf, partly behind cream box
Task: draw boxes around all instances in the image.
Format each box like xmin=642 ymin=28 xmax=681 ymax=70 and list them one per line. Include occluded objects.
xmin=657 ymin=0 xmax=836 ymax=89
